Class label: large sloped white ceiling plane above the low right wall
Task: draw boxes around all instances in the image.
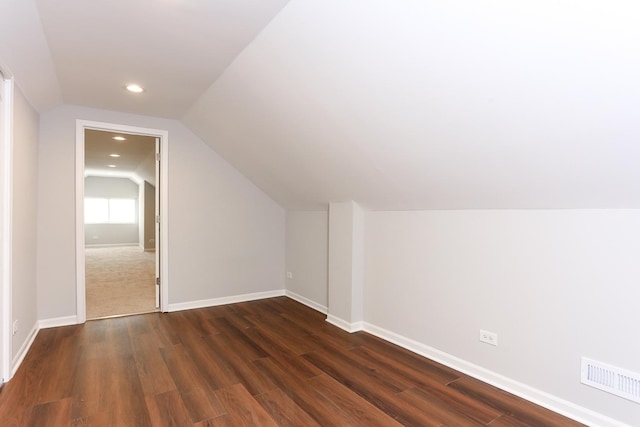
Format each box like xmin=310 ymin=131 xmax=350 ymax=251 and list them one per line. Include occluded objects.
xmin=183 ymin=0 xmax=640 ymax=209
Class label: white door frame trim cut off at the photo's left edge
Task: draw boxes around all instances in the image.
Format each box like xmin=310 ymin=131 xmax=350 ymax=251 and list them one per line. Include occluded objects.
xmin=0 ymin=67 xmax=13 ymax=382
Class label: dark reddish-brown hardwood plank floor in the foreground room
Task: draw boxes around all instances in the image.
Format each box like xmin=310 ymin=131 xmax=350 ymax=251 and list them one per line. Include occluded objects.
xmin=0 ymin=297 xmax=580 ymax=427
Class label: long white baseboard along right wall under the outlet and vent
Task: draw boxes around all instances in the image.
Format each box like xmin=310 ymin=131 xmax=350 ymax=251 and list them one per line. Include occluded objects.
xmin=362 ymin=324 xmax=629 ymax=427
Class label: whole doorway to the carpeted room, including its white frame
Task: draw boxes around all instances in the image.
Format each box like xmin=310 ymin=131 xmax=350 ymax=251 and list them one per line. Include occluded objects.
xmin=76 ymin=120 xmax=168 ymax=323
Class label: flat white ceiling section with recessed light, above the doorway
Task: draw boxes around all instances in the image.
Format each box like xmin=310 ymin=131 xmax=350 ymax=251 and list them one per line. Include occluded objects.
xmin=30 ymin=0 xmax=287 ymax=118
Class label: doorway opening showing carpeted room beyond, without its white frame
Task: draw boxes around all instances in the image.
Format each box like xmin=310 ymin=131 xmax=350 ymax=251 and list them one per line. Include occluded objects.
xmin=84 ymin=129 xmax=159 ymax=319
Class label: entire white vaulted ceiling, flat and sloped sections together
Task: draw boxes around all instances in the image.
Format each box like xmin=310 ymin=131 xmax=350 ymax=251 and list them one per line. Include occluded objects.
xmin=0 ymin=0 xmax=640 ymax=210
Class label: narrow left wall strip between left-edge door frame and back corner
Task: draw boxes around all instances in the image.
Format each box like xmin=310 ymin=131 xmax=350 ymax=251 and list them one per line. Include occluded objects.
xmin=11 ymin=85 xmax=38 ymax=364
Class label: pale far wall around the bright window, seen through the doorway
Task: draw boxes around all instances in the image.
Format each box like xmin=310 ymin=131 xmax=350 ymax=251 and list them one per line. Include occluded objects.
xmin=84 ymin=176 xmax=140 ymax=245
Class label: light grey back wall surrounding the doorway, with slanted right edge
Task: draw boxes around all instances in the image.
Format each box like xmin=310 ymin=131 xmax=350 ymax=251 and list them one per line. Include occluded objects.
xmin=38 ymin=105 xmax=285 ymax=319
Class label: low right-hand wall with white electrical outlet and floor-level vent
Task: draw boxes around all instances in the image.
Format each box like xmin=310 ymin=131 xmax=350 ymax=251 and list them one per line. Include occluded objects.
xmin=365 ymin=210 xmax=640 ymax=425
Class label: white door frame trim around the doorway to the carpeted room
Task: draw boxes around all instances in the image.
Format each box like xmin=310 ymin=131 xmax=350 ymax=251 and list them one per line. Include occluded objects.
xmin=76 ymin=120 xmax=169 ymax=323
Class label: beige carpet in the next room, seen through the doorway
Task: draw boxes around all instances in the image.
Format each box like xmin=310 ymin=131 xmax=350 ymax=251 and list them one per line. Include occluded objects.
xmin=85 ymin=246 xmax=156 ymax=319
